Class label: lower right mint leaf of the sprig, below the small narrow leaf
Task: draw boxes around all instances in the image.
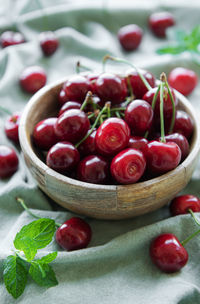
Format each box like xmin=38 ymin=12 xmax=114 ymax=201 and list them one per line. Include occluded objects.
xmin=29 ymin=261 xmax=58 ymax=287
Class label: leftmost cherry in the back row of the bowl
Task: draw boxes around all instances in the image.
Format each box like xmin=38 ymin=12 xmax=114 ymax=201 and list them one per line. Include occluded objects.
xmin=63 ymin=75 xmax=90 ymax=102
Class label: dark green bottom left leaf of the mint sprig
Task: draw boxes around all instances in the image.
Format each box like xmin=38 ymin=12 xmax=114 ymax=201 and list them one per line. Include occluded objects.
xmin=3 ymin=255 xmax=28 ymax=299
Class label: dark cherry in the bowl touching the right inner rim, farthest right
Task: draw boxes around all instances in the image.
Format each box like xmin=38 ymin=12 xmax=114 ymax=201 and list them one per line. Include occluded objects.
xmin=173 ymin=110 xmax=194 ymax=138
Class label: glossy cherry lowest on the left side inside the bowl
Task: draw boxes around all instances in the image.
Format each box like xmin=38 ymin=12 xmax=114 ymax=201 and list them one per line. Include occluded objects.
xmin=46 ymin=141 xmax=80 ymax=174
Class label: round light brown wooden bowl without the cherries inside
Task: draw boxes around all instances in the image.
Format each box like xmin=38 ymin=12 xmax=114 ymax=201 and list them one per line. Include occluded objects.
xmin=19 ymin=78 xmax=200 ymax=219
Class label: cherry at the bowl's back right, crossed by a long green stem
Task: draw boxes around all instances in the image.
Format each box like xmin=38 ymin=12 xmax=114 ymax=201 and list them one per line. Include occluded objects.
xmin=126 ymin=70 xmax=156 ymax=99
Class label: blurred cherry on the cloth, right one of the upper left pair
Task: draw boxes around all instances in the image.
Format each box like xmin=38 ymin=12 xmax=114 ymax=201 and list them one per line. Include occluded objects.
xmin=39 ymin=31 xmax=59 ymax=56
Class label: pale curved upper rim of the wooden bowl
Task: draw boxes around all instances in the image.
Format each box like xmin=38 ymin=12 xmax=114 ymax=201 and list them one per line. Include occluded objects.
xmin=19 ymin=74 xmax=200 ymax=191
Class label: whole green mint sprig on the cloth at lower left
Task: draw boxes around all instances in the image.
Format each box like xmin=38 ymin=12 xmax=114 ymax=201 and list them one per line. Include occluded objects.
xmin=3 ymin=218 xmax=58 ymax=299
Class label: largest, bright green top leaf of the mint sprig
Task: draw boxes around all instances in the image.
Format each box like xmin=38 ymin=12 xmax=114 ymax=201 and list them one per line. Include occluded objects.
xmin=14 ymin=218 xmax=56 ymax=261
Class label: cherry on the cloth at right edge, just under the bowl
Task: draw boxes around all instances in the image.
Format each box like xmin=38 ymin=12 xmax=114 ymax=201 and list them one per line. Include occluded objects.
xmin=170 ymin=194 xmax=200 ymax=215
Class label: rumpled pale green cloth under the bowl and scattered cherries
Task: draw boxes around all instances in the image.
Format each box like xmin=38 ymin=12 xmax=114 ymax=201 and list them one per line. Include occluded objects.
xmin=0 ymin=0 xmax=200 ymax=304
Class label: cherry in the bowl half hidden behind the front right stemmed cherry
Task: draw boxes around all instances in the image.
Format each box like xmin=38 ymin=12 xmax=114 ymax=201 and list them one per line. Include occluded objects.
xmin=160 ymin=133 xmax=190 ymax=160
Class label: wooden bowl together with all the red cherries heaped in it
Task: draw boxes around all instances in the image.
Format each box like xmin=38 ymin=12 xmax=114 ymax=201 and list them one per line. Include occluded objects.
xmin=19 ymin=56 xmax=200 ymax=219
